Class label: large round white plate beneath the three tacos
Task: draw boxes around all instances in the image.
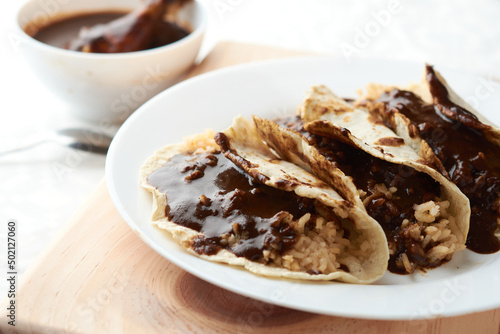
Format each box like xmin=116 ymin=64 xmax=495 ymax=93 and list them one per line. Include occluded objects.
xmin=106 ymin=57 xmax=500 ymax=319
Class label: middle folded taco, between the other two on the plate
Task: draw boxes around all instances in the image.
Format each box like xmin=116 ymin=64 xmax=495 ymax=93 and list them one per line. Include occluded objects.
xmin=254 ymin=86 xmax=470 ymax=274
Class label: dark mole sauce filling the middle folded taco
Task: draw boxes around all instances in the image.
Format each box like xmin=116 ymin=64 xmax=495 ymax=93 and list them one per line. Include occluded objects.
xmin=276 ymin=116 xmax=441 ymax=274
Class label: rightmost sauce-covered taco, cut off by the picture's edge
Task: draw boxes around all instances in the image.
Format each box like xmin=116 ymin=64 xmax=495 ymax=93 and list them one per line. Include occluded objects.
xmin=359 ymin=65 xmax=500 ymax=253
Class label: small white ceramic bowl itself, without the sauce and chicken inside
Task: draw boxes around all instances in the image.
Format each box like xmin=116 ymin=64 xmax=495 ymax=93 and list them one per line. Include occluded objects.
xmin=17 ymin=0 xmax=207 ymax=123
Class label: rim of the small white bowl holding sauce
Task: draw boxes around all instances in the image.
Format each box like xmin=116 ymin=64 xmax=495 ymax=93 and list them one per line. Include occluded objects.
xmin=15 ymin=0 xmax=208 ymax=60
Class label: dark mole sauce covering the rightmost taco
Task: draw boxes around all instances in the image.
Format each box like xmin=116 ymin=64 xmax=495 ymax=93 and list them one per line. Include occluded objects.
xmin=375 ymin=69 xmax=500 ymax=254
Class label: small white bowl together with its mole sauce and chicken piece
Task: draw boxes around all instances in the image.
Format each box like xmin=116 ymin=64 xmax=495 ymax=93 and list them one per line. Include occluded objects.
xmin=17 ymin=0 xmax=207 ymax=123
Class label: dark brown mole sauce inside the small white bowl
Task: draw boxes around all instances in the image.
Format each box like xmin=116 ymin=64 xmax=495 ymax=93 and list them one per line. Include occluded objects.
xmin=32 ymin=12 xmax=189 ymax=53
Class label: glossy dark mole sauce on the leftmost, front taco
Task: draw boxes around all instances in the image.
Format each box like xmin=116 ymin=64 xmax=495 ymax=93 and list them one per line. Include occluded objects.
xmin=148 ymin=152 xmax=314 ymax=262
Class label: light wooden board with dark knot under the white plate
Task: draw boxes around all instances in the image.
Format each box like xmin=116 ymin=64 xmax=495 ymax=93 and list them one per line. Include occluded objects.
xmin=6 ymin=42 xmax=500 ymax=334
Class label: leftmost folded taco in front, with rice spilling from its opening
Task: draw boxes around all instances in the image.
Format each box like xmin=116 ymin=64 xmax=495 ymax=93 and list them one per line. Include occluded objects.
xmin=140 ymin=118 xmax=389 ymax=283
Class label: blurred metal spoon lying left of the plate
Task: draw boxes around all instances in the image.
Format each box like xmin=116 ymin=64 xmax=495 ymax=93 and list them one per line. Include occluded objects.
xmin=0 ymin=128 xmax=112 ymax=156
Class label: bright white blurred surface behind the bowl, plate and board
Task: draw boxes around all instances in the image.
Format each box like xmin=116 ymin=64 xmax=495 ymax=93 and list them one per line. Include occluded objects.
xmin=0 ymin=0 xmax=500 ymax=292
